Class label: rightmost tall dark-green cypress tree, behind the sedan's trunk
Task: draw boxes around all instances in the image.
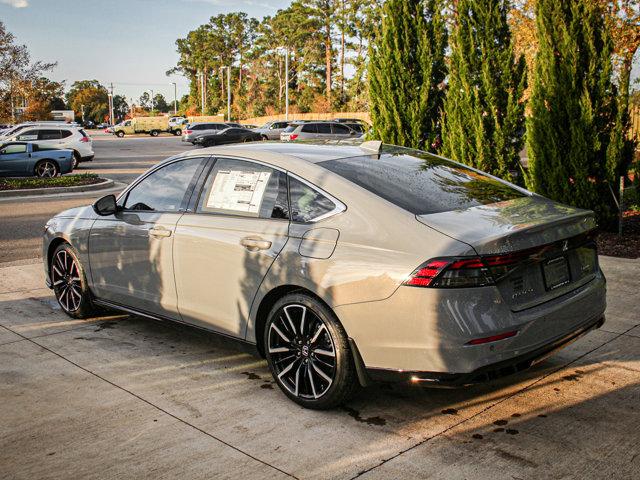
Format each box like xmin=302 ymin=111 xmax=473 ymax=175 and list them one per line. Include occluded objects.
xmin=527 ymin=0 xmax=618 ymax=227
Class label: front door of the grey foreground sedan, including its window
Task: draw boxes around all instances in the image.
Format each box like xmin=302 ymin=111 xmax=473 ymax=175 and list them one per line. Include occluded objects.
xmin=89 ymin=157 xmax=206 ymax=319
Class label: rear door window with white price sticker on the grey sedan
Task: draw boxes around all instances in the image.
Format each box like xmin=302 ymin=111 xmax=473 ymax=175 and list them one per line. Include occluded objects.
xmin=196 ymin=158 xmax=289 ymax=219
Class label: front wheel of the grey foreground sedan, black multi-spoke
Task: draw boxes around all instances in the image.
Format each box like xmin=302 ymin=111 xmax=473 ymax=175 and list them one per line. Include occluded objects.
xmin=49 ymin=243 xmax=98 ymax=318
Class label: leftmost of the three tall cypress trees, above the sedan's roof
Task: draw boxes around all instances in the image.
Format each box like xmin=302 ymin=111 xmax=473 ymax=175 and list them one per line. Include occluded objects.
xmin=369 ymin=0 xmax=447 ymax=148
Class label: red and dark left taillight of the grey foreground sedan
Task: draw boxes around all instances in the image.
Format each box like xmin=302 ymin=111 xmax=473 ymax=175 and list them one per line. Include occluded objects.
xmin=404 ymin=252 xmax=530 ymax=288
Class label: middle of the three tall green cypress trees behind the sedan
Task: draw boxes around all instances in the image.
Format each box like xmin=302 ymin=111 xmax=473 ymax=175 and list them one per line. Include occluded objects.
xmin=441 ymin=0 xmax=526 ymax=181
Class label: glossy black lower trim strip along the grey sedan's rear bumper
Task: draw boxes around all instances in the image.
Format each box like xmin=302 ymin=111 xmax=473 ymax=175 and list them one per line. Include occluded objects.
xmin=366 ymin=316 xmax=605 ymax=388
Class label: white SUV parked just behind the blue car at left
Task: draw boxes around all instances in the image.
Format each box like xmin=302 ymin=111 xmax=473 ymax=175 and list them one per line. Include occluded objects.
xmin=7 ymin=125 xmax=95 ymax=168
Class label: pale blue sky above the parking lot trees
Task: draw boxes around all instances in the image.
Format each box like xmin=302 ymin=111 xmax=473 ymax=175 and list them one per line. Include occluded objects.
xmin=0 ymin=0 xmax=290 ymax=102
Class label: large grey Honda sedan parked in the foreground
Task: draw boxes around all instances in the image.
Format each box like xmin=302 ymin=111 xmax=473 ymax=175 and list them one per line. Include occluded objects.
xmin=43 ymin=142 xmax=605 ymax=408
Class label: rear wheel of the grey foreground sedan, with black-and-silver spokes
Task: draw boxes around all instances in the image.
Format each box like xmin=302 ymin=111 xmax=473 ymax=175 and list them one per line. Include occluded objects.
xmin=263 ymin=293 xmax=359 ymax=410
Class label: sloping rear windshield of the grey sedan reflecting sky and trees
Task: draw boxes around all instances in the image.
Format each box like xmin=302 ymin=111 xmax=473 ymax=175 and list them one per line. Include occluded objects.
xmin=318 ymin=149 xmax=525 ymax=215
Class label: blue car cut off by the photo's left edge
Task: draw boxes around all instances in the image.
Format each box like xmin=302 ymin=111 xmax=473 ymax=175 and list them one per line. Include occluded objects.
xmin=0 ymin=142 xmax=73 ymax=178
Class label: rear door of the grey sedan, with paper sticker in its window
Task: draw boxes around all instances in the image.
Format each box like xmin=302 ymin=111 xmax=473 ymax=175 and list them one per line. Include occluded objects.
xmin=174 ymin=158 xmax=289 ymax=338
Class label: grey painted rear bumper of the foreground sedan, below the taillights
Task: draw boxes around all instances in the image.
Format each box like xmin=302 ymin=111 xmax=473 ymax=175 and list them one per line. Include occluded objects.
xmin=334 ymin=272 xmax=606 ymax=376
